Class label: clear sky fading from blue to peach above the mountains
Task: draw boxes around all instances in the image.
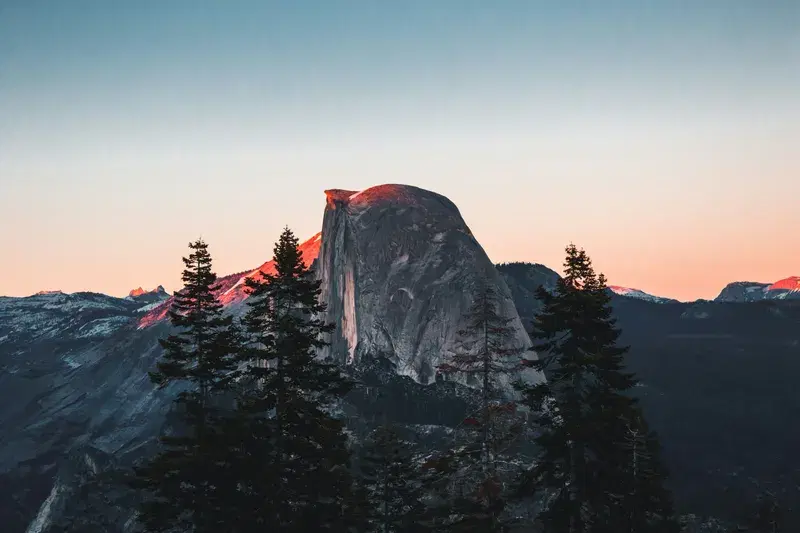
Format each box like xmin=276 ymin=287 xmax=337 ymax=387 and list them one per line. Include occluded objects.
xmin=0 ymin=0 xmax=800 ymax=300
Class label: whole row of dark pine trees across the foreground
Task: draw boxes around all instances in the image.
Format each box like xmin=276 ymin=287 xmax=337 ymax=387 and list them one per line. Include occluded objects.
xmin=57 ymin=228 xmax=692 ymax=533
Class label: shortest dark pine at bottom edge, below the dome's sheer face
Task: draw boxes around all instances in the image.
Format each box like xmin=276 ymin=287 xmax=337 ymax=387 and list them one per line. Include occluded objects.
xmin=360 ymin=425 xmax=425 ymax=533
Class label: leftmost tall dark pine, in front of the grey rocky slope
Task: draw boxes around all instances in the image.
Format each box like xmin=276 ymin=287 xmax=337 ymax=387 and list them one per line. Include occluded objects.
xmin=132 ymin=239 xmax=238 ymax=532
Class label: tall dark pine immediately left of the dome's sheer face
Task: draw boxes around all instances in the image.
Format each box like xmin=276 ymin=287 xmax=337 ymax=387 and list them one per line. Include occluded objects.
xmin=238 ymin=228 xmax=365 ymax=532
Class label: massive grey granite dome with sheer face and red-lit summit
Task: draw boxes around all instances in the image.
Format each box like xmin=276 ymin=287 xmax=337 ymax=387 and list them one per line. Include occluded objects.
xmin=317 ymin=185 xmax=539 ymax=383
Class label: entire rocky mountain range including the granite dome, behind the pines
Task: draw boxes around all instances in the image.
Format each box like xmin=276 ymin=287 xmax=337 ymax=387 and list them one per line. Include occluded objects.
xmin=0 ymin=185 xmax=800 ymax=533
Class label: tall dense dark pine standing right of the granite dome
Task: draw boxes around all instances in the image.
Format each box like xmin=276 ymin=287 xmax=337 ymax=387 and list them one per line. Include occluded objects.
xmin=517 ymin=245 xmax=674 ymax=533
